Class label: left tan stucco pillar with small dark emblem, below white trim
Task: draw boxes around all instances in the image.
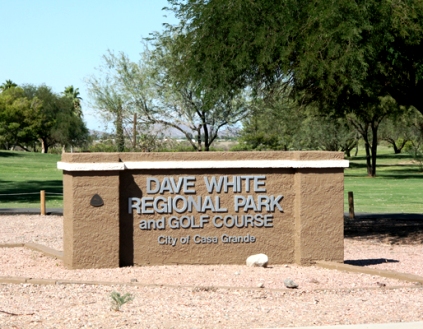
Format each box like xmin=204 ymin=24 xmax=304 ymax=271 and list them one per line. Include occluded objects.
xmin=63 ymin=172 xmax=120 ymax=268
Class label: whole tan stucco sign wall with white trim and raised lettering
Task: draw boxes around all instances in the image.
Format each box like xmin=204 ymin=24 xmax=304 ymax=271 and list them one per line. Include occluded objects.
xmin=58 ymin=152 xmax=348 ymax=268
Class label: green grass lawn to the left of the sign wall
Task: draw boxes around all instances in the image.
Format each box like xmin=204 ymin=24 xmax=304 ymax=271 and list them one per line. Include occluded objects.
xmin=0 ymin=151 xmax=63 ymax=208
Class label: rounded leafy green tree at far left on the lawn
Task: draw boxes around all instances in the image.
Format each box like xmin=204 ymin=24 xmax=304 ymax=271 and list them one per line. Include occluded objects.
xmin=0 ymin=85 xmax=88 ymax=153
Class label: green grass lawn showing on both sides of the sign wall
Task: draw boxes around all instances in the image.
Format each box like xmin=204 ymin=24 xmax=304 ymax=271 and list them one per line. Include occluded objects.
xmin=0 ymin=146 xmax=423 ymax=213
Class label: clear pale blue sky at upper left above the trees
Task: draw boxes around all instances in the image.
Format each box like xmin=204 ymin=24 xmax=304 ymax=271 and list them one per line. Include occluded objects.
xmin=0 ymin=0 xmax=176 ymax=130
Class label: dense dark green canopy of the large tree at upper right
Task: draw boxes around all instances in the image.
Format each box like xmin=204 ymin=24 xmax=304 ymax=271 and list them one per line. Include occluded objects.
xmin=167 ymin=0 xmax=423 ymax=114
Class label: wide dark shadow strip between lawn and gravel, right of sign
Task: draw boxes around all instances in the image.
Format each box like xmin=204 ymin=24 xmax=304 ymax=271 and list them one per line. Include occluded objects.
xmin=344 ymin=214 xmax=423 ymax=244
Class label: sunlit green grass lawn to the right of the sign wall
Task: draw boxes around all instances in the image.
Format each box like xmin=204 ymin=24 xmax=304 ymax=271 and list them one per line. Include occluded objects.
xmin=344 ymin=146 xmax=423 ymax=213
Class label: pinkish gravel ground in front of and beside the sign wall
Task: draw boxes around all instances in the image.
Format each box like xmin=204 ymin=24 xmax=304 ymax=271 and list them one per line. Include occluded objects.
xmin=0 ymin=215 xmax=423 ymax=329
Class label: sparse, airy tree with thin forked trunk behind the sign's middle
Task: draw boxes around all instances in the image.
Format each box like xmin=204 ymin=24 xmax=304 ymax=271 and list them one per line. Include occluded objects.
xmin=151 ymin=33 xmax=251 ymax=151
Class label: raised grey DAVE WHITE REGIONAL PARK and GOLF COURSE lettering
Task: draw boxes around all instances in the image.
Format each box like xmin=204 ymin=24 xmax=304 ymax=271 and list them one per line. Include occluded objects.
xmin=128 ymin=176 xmax=283 ymax=231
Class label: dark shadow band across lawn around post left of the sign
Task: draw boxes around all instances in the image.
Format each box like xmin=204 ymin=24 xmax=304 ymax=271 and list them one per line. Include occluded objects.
xmin=0 ymin=180 xmax=63 ymax=207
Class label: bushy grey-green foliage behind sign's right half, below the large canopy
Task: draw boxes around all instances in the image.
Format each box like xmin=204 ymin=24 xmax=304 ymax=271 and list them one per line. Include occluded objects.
xmin=237 ymin=97 xmax=358 ymax=156
